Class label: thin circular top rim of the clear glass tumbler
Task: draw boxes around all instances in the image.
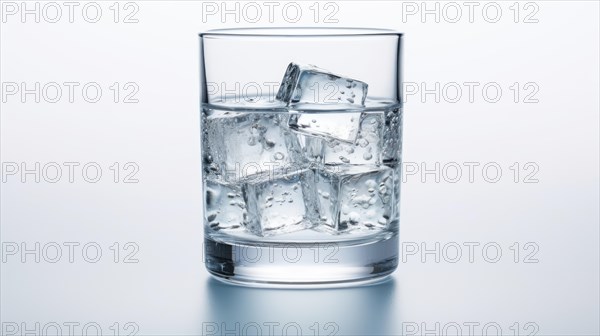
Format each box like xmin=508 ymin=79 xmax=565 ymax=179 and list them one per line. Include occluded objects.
xmin=199 ymin=27 xmax=403 ymax=38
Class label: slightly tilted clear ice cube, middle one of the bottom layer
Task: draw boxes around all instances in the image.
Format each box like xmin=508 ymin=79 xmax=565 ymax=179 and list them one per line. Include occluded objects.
xmin=242 ymin=169 xmax=318 ymax=237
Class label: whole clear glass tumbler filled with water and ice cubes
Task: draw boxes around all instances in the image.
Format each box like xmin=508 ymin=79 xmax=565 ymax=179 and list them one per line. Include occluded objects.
xmin=200 ymin=28 xmax=402 ymax=287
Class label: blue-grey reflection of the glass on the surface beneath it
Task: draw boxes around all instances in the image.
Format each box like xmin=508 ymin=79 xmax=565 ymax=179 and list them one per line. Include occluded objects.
xmin=202 ymin=278 xmax=400 ymax=335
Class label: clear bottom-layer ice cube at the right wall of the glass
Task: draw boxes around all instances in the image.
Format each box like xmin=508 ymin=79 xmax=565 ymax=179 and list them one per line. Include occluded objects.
xmin=316 ymin=166 xmax=395 ymax=232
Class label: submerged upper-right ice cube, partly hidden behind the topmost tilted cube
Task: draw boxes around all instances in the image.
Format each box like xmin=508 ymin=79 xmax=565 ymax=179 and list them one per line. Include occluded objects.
xmin=321 ymin=112 xmax=385 ymax=166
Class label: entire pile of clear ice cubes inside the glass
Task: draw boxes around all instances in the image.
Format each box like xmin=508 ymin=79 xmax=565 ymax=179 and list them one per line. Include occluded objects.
xmin=203 ymin=63 xmax=399 ymax=237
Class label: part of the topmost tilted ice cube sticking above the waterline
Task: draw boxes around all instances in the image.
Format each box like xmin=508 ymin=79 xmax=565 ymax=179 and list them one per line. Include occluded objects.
xmin=275 ymin=63 xmax=368 ymax=108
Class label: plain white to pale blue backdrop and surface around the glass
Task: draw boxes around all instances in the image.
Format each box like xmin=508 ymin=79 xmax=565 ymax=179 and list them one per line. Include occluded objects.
xmin=0 ymin=1 xmax=600 ymax=335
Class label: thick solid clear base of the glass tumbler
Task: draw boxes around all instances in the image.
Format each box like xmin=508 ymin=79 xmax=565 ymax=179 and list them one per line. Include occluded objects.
xmin=204 ymin=234 xmax=399 ymax=288
